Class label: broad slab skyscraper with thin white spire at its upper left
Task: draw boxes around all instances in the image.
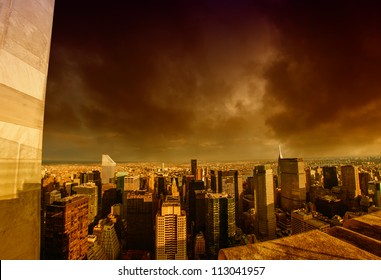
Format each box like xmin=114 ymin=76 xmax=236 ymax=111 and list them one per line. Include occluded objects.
xmin=278 ymin=154 xmax=306 ymax=211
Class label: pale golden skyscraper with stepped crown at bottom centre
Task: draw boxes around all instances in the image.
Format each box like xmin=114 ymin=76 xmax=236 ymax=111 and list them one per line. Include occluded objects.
xmin=155 ymin=196 xmax=187 ymax=260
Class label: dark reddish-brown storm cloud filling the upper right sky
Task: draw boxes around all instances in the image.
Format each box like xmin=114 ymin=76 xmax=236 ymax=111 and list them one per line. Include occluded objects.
xmin=264 ymin=1 xmax=381 ymax=155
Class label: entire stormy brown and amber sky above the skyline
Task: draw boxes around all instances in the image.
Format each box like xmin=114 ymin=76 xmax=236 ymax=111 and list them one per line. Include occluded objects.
xmin=43 ymin=0 xmax=381 ymax=162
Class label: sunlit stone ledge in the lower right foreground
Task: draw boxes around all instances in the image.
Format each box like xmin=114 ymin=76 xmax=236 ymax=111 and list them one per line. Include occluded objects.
xmin=218 ymin=211 xmax=381 ymax=260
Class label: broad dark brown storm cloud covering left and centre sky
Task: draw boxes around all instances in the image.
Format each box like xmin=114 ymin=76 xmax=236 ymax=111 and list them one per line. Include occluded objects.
xmin=45 ymin=1 xmax=269 ymax=162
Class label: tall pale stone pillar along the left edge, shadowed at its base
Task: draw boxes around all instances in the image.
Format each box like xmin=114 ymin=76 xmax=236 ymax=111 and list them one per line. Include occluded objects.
xmin=0 ymin=0 xmax=54 ymax=260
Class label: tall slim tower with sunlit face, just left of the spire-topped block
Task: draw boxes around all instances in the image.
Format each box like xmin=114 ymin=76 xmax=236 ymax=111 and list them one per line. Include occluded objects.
xmin=253 ymin=165 xmax=276 ymax=240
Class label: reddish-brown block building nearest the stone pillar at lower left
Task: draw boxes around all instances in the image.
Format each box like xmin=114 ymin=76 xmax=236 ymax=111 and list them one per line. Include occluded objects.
xmin=44 ymin=195 xmax=89 ymax=260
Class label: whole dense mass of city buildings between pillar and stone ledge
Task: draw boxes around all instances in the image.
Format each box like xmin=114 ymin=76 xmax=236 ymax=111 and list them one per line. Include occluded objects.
xmin=41 ymin=153 xmax=381 ymax=259
